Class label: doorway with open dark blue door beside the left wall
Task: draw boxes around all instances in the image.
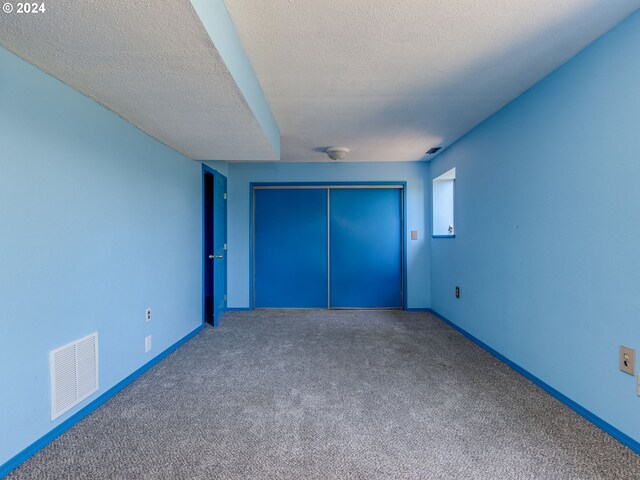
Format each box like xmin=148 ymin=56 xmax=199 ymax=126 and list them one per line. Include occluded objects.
xmin=202 ymin=165 xmax=227 ymax=327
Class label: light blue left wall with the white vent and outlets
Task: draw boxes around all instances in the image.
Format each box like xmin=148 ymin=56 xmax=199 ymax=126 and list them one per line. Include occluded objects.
xmin=0 ymin=49 xmax=202 ymax=465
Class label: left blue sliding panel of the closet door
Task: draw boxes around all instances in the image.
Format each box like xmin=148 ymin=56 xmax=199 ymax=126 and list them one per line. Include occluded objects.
xmin=254 ymin=188 xmax=328 ymax=308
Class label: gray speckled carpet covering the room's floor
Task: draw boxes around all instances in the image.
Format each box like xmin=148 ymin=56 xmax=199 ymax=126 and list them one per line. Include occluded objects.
xmin=9 ymin=310 xmax=640 ymax=480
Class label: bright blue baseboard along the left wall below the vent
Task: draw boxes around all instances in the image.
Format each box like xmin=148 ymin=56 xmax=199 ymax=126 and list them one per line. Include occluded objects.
xmin=0 ymin=325 xmax=204 ymax=479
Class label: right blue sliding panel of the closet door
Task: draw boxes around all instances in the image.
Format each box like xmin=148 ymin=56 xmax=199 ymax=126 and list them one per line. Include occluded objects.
xmin=329 ymin=188 xmax=403 ymax=308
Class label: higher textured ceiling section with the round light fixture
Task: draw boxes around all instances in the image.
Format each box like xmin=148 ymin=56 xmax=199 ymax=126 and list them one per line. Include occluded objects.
xmin=225 ymin=0 xmax=640 ymax=161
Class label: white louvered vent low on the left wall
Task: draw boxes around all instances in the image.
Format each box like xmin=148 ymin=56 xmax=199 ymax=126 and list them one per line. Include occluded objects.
xmin=49 ymin=332 xmax=98 ymax=420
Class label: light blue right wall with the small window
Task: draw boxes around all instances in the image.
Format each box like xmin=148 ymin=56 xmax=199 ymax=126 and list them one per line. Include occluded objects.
xmin=431 ymin=13 xmax=640 ymax=440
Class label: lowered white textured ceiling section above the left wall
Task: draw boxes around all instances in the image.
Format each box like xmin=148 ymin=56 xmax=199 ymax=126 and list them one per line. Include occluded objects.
xmin=0 ymin=0 xmax=277 ymax=160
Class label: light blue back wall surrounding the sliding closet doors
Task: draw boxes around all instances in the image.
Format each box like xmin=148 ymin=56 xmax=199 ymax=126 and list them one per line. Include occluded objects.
xmin=227 ymin=162 xmax=431 ymax=308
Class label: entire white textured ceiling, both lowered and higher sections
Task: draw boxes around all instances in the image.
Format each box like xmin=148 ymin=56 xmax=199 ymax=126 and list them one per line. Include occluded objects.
xmin=0 ymin=0 xmax=640 ymax=161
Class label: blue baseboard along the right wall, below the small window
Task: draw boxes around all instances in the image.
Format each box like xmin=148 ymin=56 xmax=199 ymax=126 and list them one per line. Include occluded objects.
xmin=430 ymin=309 xmax=640 ymax=455
